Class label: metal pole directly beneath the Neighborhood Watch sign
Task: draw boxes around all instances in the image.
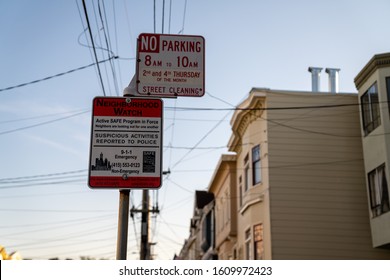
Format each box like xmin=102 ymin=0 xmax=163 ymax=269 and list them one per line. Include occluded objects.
xmin=116 ymin=190 xmax=130 ymax=260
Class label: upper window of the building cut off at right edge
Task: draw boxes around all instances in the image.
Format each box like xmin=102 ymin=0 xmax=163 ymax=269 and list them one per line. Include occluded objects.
xmin=361 ymin=83 xmax=381 ymax=135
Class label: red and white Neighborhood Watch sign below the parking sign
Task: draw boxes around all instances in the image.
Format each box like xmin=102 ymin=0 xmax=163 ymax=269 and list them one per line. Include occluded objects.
xmin=88 ymin=97 xmax=163 ymax=189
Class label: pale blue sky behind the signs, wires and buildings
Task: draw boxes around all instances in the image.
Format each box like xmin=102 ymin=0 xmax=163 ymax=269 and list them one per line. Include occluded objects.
xmin=0 ymin=0 xmax=390 ymax=259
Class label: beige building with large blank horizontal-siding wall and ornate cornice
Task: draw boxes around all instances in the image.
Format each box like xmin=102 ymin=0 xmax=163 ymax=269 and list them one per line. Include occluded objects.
xmin=227 ymin=88 xmax=390 ymax=259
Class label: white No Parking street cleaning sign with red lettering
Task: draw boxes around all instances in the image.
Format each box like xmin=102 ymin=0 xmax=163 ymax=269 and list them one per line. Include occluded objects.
xmin=136 ymin=33 xmax=205 ymax=97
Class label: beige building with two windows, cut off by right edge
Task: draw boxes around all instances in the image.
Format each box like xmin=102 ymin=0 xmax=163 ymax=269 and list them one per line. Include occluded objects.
xmin=355 ymin=53 xmax=390 ymax=248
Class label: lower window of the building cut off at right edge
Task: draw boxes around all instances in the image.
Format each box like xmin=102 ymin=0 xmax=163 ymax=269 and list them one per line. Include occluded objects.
xmin=368 ymin=164 xmax=390 ymax=217
